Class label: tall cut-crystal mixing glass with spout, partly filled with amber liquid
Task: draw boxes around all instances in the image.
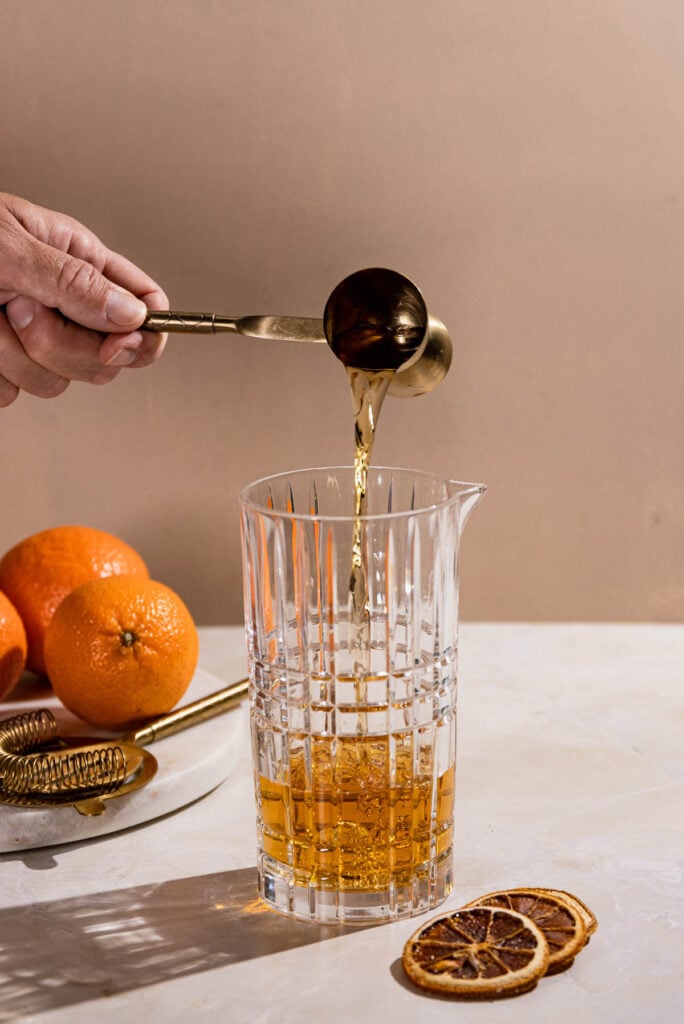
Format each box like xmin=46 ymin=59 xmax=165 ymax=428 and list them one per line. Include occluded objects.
xmin=241 ymin=467 xmax=484 ymax=923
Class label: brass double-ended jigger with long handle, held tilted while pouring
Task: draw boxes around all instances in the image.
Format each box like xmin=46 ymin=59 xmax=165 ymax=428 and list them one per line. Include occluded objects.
xmin=141 ymin=269 xmax=452 ymax=398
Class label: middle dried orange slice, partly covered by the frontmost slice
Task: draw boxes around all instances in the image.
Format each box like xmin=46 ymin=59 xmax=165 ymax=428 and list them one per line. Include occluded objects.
xmin=466 ymin=889 xmax=587 ymax=974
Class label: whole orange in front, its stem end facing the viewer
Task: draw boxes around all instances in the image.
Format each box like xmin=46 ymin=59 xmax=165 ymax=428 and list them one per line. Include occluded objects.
xmin=45 ymin=577 xmax=199 ymax=731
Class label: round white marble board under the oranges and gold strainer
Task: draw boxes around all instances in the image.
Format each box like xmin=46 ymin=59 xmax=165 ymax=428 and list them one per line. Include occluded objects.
xmin=0 ymin=669 xmax=249 ymax=853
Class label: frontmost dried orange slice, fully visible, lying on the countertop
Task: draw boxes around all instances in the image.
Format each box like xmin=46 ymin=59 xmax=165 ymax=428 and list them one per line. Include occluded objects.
xmin=401 ymin=906 xmax=549 ymax=999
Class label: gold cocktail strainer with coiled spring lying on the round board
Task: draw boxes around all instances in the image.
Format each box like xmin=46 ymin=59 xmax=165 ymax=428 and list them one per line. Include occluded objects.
xmin=0 ymin=679 xmax=249 ymax=815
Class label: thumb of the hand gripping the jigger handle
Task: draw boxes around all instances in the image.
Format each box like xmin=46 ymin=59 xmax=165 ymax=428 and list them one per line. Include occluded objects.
xmin=20 ymin=240 xmax=147 ymax=334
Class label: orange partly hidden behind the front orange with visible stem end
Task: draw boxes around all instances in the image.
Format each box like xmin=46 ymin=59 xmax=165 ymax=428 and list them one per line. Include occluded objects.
xmin=0 ymin=526 xmax=149 ymax=672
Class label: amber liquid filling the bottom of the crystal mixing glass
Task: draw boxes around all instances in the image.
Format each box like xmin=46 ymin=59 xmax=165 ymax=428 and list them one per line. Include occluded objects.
xmin=259 ymin=720 xmax=454 ymax=891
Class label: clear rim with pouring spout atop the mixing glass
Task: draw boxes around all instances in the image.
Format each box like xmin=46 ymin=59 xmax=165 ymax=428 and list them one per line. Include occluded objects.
xmin=239 ymin=465 xmax=486 ymax=523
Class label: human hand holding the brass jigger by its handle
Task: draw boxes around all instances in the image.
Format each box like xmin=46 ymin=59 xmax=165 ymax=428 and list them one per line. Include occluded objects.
xmin=0 ymin=193 xmax=169 ymax=407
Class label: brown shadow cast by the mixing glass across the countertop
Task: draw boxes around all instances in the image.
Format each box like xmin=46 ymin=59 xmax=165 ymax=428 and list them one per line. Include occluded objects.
xmin=0 ymin=867 xmax=358 ymax=1022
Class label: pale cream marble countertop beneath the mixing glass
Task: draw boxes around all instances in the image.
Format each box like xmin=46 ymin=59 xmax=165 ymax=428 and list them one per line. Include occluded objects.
xmin=0 ymin=624 xmax=684 ymax=1024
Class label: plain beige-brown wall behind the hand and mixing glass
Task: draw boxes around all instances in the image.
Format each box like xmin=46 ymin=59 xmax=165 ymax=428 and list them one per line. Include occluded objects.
xmin=0 ymin=0 xmax=684 ymax=624
